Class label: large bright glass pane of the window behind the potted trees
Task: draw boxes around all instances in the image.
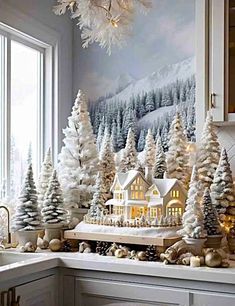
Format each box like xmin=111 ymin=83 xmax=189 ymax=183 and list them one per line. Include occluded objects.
xmin=10 ymin=41 xmax=41 ymax=196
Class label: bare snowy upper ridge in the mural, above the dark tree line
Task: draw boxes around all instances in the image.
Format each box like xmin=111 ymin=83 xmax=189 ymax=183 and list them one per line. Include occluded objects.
xmin=98 ymin=57 xmax=195 ymax=103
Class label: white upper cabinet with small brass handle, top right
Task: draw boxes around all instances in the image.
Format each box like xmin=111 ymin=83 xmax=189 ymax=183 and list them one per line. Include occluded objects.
xmin=195 ymin=0 xmax=235 ymax=126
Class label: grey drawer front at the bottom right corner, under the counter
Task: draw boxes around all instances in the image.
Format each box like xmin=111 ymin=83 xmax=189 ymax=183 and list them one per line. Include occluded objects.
xmin=192 ymin=292 xmax=235 ymax=306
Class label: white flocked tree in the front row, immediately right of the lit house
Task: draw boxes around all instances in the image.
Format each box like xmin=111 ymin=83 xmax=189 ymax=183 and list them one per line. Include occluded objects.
xmin=179 ymin=167 xmax=205 ymax=239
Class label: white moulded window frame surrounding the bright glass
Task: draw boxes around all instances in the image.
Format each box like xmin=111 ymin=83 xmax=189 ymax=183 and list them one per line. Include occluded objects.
xmin=0 ymin=16 xmax=59 ymax=198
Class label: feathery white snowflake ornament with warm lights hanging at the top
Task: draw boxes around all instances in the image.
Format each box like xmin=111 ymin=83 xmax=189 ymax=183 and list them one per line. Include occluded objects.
xmin=53 ymin=0 xmax=151 ymax=55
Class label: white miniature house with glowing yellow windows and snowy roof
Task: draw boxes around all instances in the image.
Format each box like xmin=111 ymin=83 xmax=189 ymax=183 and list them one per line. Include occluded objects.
xmin=106 ymin=170 xmax=187 ymax=220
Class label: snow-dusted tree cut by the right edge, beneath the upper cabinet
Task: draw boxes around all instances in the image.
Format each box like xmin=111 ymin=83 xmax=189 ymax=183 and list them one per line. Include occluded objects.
xmin=211 ymin=148 xmax=234 ymax=215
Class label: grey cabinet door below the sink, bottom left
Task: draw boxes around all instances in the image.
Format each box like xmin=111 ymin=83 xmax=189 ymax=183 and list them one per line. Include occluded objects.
xmin=15 ymin=275 xmax=58 ymax=306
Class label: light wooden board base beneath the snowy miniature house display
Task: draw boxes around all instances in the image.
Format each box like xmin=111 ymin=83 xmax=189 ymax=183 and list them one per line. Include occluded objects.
xmin=64 ymin=230 xmax=181 ymax=251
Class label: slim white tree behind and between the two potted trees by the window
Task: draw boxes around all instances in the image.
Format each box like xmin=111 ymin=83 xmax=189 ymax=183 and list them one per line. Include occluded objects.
xmin=37 ymin=148 xmax=53 ymax=207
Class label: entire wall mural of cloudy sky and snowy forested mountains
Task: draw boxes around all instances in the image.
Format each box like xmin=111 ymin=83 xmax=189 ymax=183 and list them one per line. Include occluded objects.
xmin=78 ymin=0 xmax=196 ymax=152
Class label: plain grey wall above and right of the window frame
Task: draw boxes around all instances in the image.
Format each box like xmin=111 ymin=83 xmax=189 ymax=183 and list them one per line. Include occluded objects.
xmin=0 ymin=0 xmax=73 ymax=152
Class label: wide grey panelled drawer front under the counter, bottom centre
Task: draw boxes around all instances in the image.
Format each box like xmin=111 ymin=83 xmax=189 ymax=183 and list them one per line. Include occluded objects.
xmin=75 ymin=278 xmax=189 ymax=306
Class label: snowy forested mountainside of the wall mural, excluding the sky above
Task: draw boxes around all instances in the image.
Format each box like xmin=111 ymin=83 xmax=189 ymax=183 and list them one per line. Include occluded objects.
xmin=90 ymin=58 xmax=195 ymax=151
